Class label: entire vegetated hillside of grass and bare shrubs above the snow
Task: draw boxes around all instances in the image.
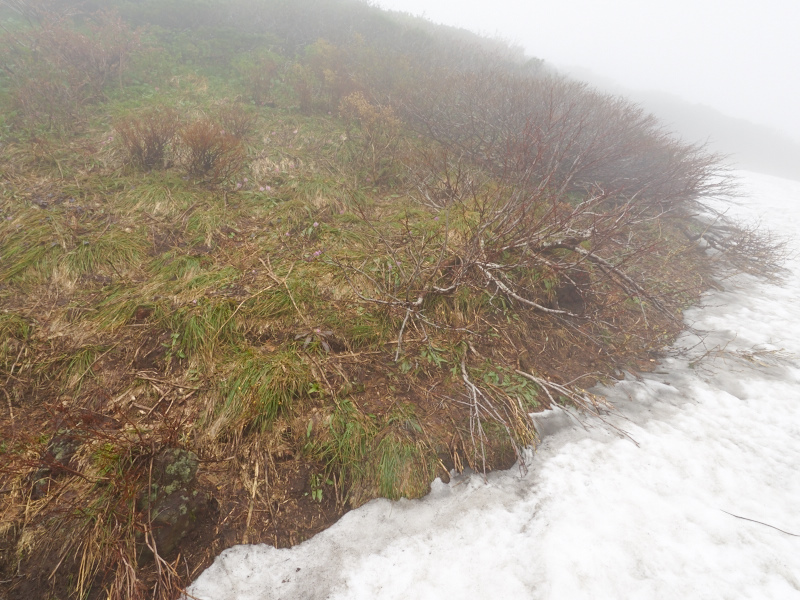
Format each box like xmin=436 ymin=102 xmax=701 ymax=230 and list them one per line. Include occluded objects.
xmin=0 ymin=0 xmax=773 ymax=598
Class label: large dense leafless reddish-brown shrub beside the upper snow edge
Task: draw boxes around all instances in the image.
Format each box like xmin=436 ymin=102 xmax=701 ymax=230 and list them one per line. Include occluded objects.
xmin=396 ymin=68 xmax=721 ymax=210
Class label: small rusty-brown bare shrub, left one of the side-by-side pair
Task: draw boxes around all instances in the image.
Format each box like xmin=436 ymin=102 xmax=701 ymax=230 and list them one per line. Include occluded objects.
xmin=114 ymin=108 xmax=178 ymax=171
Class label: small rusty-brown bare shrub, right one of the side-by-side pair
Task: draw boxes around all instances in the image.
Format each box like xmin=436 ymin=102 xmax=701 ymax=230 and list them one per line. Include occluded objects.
xmin=179 ymin=118 xmax=245 ymax=184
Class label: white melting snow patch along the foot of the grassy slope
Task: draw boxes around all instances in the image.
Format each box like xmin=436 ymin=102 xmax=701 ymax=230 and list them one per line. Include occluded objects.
xmin=189 ymin=173 xmax=800 ymax=600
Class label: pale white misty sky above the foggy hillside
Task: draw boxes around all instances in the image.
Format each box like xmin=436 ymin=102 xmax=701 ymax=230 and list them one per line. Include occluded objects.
xmin=373 ymin=0 xmax=800 ymax=141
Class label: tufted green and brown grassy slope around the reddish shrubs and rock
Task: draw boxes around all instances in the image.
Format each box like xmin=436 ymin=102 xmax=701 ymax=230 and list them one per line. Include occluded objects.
xmin=0 ymin=3 xmax=736 ymax=597
